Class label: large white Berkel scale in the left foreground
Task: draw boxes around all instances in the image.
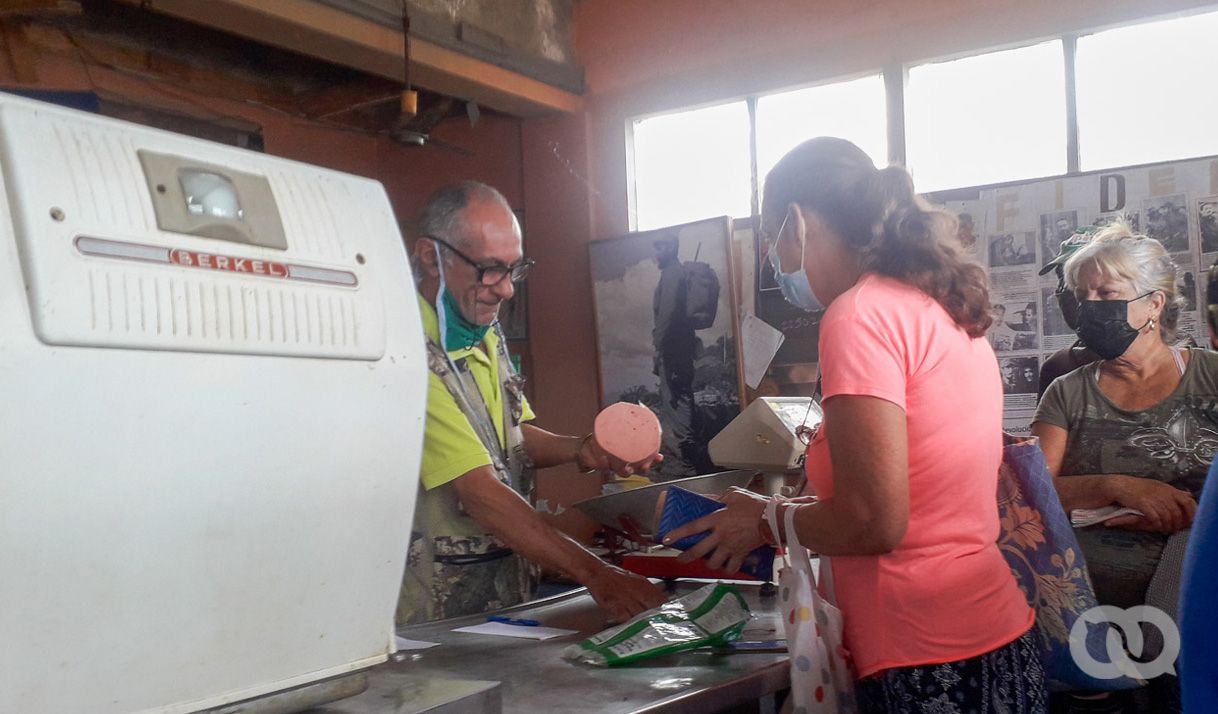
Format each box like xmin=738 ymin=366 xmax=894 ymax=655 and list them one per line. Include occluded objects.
xmin=0 ymin=94 xmax=426 ymax=714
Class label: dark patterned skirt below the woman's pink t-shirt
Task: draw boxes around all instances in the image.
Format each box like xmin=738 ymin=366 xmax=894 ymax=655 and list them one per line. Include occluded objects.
xmin=855 ymin=629 xmax=1049 ymax=714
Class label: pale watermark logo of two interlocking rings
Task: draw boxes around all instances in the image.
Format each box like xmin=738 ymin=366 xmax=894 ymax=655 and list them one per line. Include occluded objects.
xmin=1069 ymin=604 xmax=1180 ymax=680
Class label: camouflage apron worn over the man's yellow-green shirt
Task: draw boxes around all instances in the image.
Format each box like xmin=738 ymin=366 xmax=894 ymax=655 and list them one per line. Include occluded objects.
xmin=397 ymin=324 xmax=540 ymax=625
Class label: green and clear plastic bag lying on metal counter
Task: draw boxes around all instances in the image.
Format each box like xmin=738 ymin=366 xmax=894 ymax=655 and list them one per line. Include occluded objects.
xmin=563 ymin=584 xmax=753 ymax=666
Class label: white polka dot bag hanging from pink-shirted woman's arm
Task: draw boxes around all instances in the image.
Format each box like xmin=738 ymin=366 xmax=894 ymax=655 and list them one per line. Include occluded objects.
xmin=766 ymin=498 xmax=857 ymax=714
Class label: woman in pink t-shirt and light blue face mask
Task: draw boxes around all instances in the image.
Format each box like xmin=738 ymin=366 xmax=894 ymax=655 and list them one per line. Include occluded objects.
xmin=670 ymin=138 xmax=1045 ymax=714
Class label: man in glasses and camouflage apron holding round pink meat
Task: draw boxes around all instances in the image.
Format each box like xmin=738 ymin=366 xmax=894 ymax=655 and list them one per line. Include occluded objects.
xmin=397 ymin=182 xmax=664 ymax=624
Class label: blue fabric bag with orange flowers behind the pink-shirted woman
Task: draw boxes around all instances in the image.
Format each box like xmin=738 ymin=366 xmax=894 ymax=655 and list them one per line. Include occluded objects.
xmin=998 ymin=434 xmax=1145 ymax=691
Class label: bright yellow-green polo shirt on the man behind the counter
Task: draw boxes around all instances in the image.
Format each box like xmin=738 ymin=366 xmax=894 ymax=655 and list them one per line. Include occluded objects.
xmin=419 ymin=295 xmax=533 ymax=490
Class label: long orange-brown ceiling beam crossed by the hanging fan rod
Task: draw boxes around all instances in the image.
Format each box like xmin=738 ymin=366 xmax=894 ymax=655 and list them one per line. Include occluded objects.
xmin=119 ymin=0 xmax=582 ymax=117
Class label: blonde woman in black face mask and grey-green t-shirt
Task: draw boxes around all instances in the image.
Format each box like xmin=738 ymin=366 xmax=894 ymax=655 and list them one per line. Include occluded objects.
xmin=1032 ymin=223 xmax=1218 ymax=712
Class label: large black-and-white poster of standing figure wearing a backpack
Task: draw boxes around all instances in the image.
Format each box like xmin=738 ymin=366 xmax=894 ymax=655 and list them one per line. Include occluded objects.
xmin=588 ymin=217 xmax=741 ymax=479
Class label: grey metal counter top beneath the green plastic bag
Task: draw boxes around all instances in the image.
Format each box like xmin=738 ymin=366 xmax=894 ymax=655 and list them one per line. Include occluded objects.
xmin=312 ymin=581 xmax=790 ymax=714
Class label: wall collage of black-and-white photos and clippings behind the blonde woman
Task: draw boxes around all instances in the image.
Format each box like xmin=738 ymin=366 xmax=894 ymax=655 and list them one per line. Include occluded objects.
xmin=945 ymin=158 xmax=1218 ymax=435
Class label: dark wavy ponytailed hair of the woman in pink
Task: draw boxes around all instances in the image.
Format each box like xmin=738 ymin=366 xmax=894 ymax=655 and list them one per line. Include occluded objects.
xmin=761 ymin=136 xmax=993 ymax=338
